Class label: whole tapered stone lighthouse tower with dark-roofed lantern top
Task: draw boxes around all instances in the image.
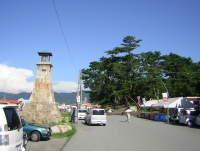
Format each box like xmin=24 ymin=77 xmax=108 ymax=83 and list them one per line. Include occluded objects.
xmin=22 ymin=51 xmax=62 ymax=123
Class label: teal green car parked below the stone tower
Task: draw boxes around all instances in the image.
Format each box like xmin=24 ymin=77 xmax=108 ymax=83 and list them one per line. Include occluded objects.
xmin=22 ymin=119 xmax=52 ymax=142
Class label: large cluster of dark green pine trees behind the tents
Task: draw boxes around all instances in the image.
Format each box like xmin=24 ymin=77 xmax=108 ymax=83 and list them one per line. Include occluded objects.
xmin=82 ymin=36 xmax=200 ymax=107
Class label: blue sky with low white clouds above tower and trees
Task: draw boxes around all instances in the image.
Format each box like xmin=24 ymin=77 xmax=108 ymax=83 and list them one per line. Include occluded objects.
xmin=0 ymin=0 xmax=200 ymax=93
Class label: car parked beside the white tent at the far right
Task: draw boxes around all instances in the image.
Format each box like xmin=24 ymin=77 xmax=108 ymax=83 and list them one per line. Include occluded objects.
xmin=179 ymin=110 xmax=200 ymax=127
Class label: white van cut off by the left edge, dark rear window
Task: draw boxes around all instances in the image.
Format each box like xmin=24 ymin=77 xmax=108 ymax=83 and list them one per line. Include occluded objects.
xmin=0 ymin=102 xmax=27 ymax=151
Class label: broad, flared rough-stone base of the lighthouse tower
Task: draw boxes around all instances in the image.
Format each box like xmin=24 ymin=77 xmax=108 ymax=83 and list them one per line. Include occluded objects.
xmin=22 ymin=101 xmax=62 ymax=123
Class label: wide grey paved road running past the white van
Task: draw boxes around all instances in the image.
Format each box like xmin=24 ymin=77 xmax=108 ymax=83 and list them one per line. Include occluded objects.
xmin=62 ymin=116 xmax=200 ymax=151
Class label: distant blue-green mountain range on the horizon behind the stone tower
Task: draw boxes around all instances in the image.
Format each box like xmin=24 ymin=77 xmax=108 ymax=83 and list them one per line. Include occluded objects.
xmin=0 ymin=91 xmax=89 ymax=104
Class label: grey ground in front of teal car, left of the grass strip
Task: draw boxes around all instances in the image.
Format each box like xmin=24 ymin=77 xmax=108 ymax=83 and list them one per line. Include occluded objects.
xmin=26 ymin=137 xmax=67 ymax=151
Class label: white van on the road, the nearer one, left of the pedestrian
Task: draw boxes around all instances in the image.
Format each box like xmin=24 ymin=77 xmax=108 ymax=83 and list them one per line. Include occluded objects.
xmin=85 ymin=108 xmax=107 ymax=126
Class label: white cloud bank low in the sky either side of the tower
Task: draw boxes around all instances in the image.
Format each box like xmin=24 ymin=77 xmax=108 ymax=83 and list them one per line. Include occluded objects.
xmin=0 ymin=64 xmax=78 ymax=94
